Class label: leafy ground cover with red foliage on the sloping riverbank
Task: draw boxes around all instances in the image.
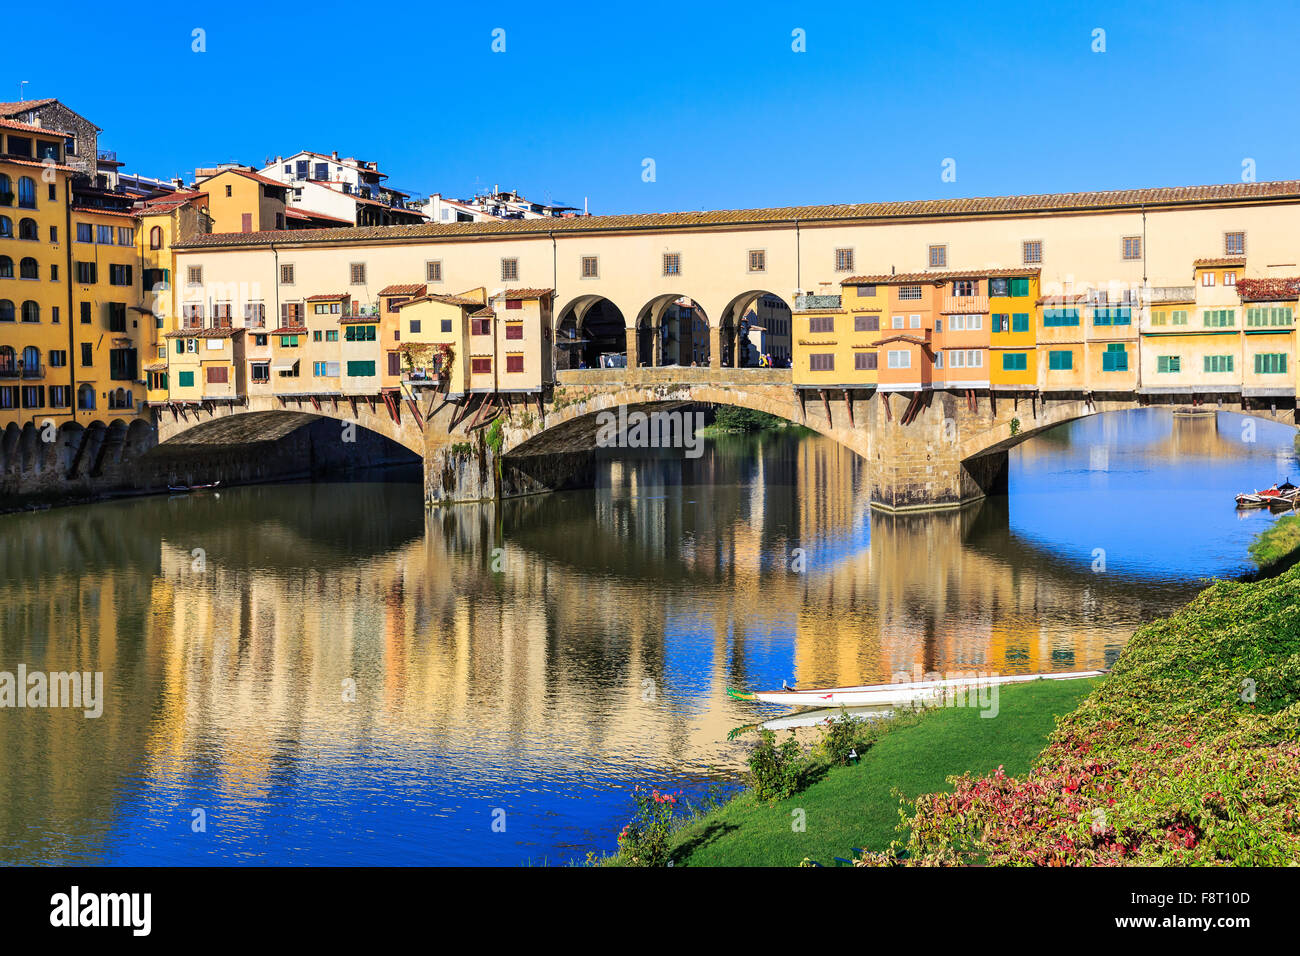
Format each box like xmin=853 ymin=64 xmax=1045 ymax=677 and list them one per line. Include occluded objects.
xmin=870 ymin=567 xmax=1300 ymax=866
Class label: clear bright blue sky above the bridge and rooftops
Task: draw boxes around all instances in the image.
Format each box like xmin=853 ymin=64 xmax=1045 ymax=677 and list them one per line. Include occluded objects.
xmin=10 ymin=0 xmax=1300 ymax=213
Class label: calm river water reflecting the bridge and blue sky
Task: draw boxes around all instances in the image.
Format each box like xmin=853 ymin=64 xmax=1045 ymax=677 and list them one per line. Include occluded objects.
xmin=0 ymin=411 xmax=1300 ymax=865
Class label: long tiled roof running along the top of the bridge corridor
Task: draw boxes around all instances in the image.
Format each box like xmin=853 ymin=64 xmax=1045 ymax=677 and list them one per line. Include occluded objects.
xmin=178 ymin=179 xmax=1300 ymax=248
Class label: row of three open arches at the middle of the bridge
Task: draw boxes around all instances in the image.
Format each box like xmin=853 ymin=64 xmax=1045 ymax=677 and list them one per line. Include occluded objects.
xmin=555 ymin=289 xmax=792 ymax=369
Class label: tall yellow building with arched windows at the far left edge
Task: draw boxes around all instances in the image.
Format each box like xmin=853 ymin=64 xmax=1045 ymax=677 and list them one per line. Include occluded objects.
xmin=0 ymin=120 xmax=75 ymax=429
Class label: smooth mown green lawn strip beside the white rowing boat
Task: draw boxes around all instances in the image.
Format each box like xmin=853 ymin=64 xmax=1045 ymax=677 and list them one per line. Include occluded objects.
xmin=611 ymin=680 xmax=1097 ymax=866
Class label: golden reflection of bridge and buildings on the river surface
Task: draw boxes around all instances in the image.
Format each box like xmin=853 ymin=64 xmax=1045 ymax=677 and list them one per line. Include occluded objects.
xmin=0 ymin=438 xmax=1190 ymax=860
